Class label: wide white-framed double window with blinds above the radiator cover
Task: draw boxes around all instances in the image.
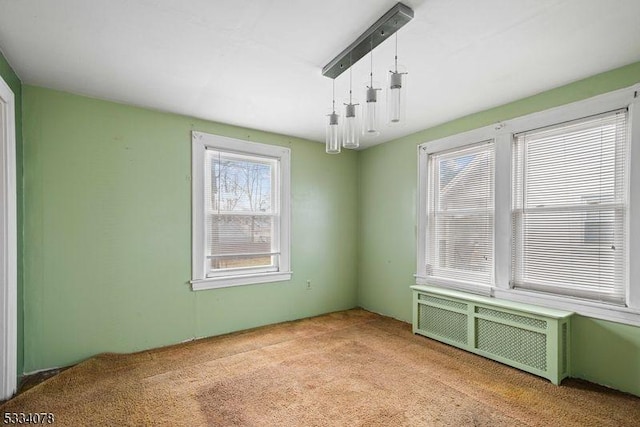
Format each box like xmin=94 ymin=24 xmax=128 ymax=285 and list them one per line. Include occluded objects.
xmin=416 ymin=85 xmax=640 ymax=326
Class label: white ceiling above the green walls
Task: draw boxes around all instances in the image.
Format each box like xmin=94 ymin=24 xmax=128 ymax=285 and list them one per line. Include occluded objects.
xmin=0 ymin=0 xmax=640 ymax=147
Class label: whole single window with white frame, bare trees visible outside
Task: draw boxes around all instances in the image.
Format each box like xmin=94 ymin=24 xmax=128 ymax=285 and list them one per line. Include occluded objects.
xmin=191 ymin=132 xmax=291 ymax=290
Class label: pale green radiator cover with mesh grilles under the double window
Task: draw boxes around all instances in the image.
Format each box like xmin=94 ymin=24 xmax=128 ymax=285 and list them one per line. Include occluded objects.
xmin=411 ymin=285 xmax=573 ymax=384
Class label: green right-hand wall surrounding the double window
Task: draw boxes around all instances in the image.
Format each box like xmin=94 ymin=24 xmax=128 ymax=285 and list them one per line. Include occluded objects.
xmin=358 ymin=63 xmax=640 ymax=395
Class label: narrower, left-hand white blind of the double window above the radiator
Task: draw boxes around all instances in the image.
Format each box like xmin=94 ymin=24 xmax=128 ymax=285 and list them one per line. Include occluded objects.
xmin=426 ymin=140 xmax=495 ymax=285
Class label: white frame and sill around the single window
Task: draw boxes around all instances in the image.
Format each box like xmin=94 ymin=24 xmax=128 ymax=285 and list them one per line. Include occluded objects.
xmin=190 ymin=131 xmax=292 ymax=291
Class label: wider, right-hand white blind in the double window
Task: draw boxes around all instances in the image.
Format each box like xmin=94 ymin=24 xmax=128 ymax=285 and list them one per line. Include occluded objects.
xmin=511 ymin=110 xmax=628 ymax=304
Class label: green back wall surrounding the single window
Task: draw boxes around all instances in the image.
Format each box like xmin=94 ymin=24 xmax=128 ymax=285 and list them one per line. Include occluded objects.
xmin=23 ymin=85 xmax=358 ymax=372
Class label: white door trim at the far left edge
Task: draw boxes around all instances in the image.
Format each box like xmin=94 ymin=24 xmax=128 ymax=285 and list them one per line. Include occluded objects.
xmin=0 ymin=74 xmax=18 ymax=400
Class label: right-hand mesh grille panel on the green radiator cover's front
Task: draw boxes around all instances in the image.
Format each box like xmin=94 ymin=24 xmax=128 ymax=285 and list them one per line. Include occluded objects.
xmin=476 ymin=319 xmax=547 ymax=371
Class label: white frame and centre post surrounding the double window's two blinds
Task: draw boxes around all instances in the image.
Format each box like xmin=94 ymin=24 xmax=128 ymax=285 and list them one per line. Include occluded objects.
xmin=416 ymin=84 xmax=640 ymax=326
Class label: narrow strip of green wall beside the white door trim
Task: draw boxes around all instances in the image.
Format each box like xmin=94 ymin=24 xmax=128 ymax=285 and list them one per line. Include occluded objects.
xmin=0 ymin=52 xmax=24 ymax=375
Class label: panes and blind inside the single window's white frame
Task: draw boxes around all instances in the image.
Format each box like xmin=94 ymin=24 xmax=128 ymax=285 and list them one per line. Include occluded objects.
xmin=205 ymin=149 xmax=280 ymax=276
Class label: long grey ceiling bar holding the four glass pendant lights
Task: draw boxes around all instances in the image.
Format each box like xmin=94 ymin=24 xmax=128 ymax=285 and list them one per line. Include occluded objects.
xmin=322 ymin=3 xmax=413 ymax=79
